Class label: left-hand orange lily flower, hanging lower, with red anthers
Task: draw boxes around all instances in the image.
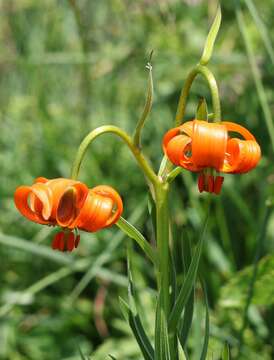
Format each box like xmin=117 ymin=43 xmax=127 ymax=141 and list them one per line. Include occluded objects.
xmin=14 ymin=177 xmax=123 ymax=251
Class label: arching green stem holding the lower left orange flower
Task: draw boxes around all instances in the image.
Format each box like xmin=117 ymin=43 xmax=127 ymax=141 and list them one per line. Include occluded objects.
xmin=71 ymin=125 xmax=159 ymax=184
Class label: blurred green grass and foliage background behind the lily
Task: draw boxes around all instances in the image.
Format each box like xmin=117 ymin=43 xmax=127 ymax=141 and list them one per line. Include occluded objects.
xmin=0 ymin=0 xmax=274 ymax=360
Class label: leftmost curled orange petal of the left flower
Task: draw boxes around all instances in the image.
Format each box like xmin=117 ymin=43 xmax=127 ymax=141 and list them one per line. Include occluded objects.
xmin=14 ymin=183 xmax=52 ymax=224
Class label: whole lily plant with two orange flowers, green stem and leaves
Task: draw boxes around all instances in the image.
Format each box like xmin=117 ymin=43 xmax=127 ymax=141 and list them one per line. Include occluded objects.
xmin=15 ymin=7 xmax=261 ymax=360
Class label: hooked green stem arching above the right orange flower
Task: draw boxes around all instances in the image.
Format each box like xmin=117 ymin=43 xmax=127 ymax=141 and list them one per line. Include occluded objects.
xmin=175 ymin=64 xmax=221 ymax=126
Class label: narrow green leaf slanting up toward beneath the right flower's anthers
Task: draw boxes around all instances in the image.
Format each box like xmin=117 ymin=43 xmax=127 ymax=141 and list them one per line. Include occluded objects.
xmin=168 ymin=214 xmax=208 ymax=330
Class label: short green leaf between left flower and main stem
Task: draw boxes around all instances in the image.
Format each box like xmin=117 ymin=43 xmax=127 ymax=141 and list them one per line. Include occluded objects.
xmin=116 ymin=217 xmax=157 ymax=265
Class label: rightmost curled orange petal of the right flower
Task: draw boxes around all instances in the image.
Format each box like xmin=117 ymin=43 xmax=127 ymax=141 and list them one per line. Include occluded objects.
xmin=222 ymin=138 xmax=261 ymax=173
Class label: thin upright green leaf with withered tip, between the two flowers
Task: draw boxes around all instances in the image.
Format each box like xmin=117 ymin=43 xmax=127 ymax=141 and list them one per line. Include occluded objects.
xmin=133 ymin=58 xmax=153 ymax=149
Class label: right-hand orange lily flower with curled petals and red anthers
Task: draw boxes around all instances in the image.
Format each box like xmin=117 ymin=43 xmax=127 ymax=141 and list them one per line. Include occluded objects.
xmin=163 ymin=120 xmax=261 ymax=194
